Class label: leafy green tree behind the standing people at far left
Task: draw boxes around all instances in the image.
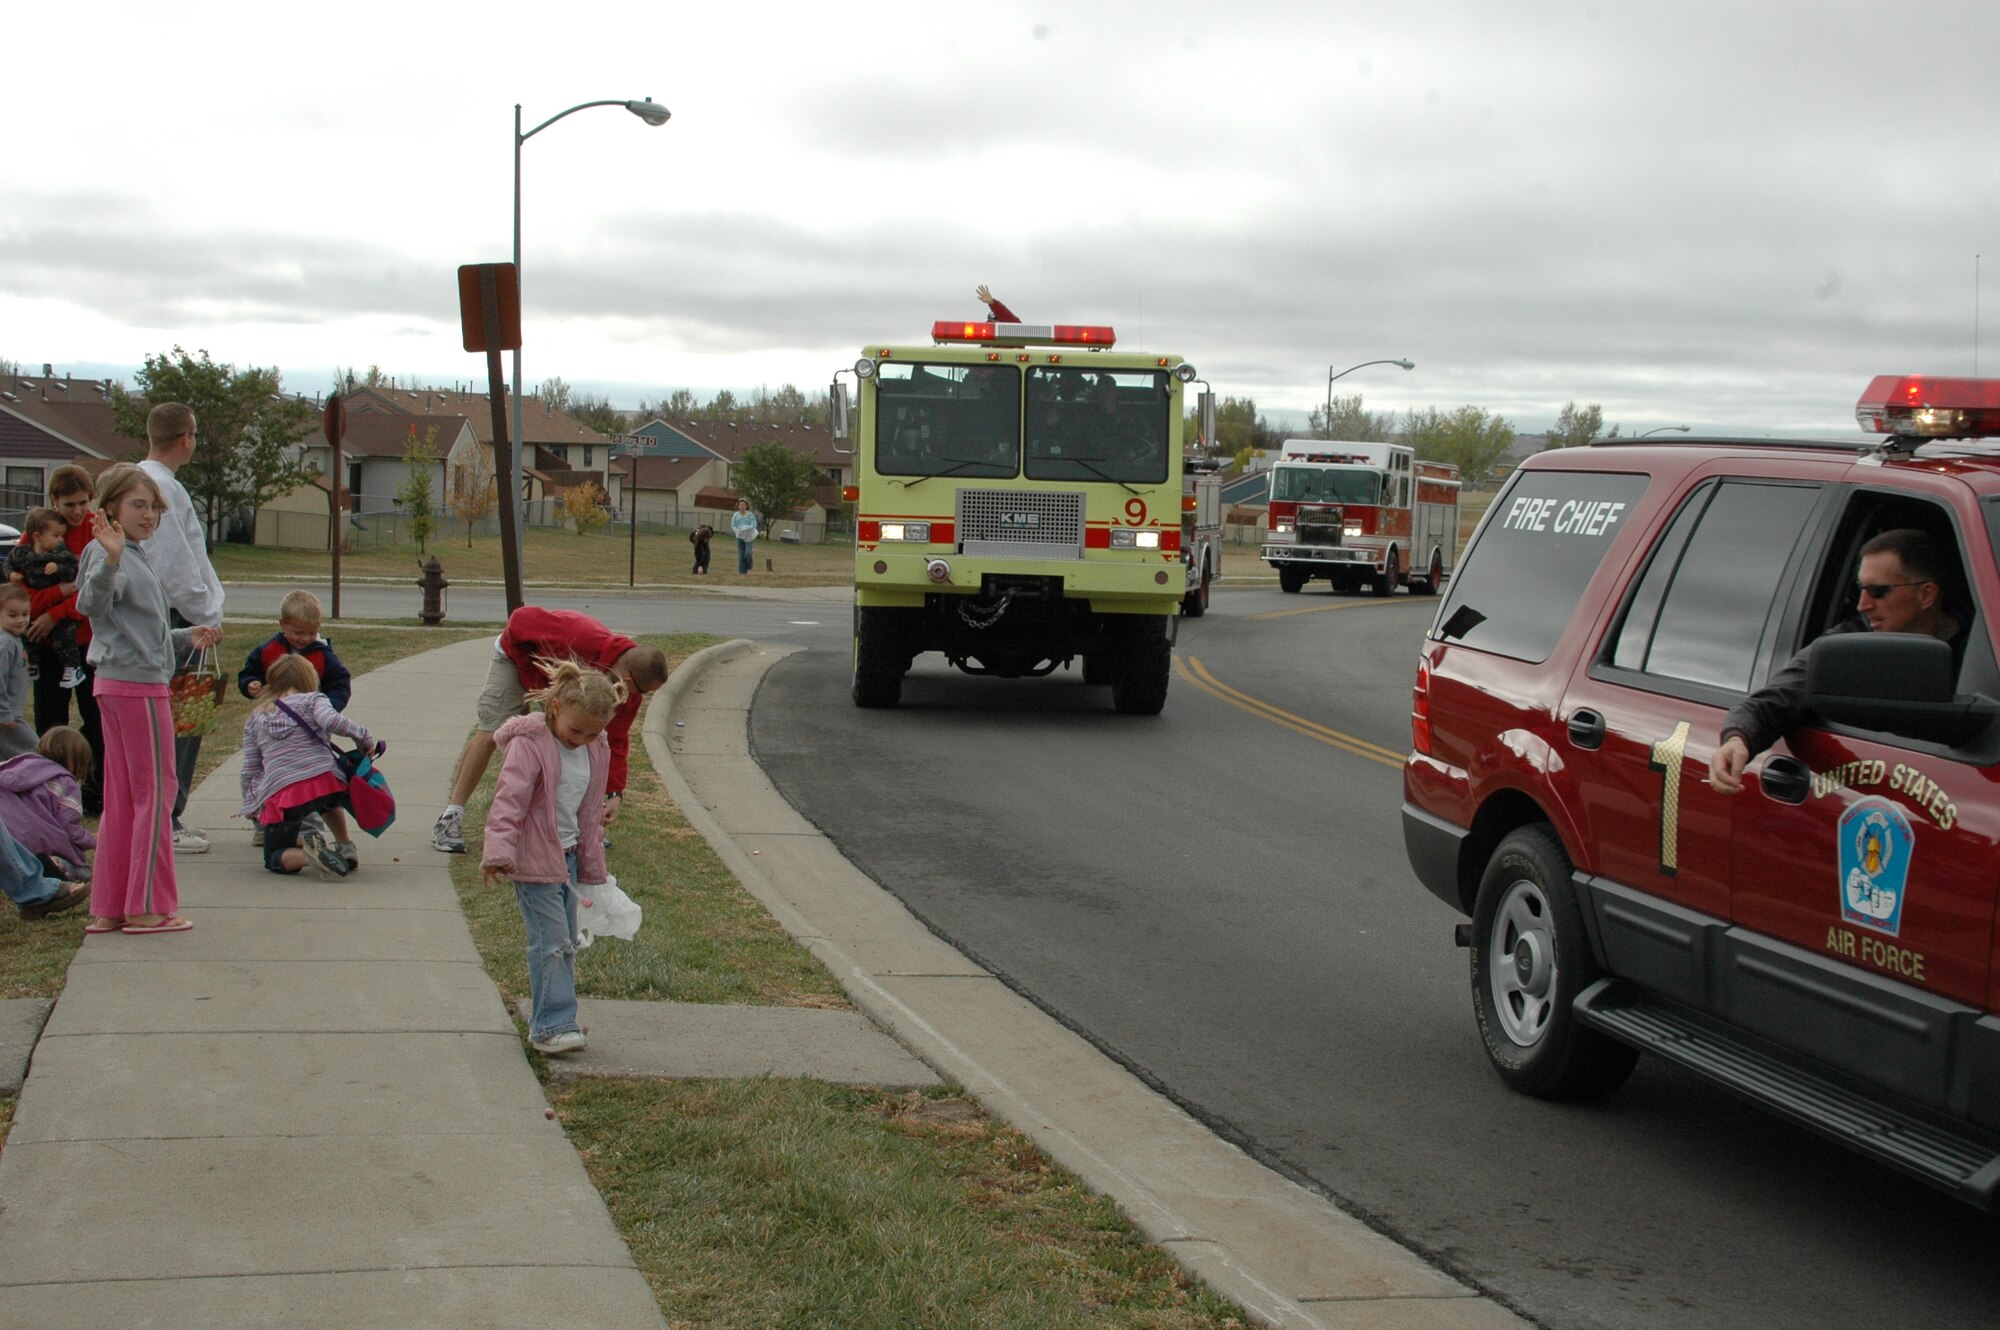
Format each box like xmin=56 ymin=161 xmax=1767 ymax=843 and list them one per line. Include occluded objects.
xmin=112 ymin=346 xmax=316 ymax=548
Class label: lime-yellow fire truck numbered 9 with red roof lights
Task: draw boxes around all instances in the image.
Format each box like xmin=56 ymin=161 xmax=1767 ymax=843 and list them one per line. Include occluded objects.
xmin=834 ymin=322 xmax=1212 ymax=716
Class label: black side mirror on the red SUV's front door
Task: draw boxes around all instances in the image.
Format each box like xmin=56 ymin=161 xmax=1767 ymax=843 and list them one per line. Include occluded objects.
xmin=1806 ymin=632 xmax=1994 ymax=744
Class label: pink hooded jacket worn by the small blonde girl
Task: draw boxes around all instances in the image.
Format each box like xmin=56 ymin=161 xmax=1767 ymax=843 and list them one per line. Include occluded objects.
xmin=480 ymin=712 xmax=612 ymax=886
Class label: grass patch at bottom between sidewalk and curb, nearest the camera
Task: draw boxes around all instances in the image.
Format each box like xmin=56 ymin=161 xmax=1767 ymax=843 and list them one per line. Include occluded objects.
xmin=550 ymin=1080 xmax=1244 ymax=1330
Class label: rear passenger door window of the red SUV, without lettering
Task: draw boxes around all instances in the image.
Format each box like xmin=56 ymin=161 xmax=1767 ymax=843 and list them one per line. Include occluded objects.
xmin=1612 ymin=480 xmax=1820 ymax=692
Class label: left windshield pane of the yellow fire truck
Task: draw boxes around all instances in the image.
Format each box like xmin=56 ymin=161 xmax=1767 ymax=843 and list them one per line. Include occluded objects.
xmin=874 ymin=360 xmax=1020 ymax=480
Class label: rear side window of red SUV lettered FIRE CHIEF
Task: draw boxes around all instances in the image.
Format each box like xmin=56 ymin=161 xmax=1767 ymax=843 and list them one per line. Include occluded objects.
xmin=1434 ymin=472 xmax=1650 ymax=662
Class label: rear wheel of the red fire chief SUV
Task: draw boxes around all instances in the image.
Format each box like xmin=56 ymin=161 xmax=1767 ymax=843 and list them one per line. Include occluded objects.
xmin=1472 ymin=826 xmax=1638 ymax=1100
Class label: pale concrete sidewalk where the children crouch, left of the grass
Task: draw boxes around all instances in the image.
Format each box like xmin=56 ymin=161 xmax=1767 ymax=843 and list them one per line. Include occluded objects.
xmin=0 ymin=640 xmax=664 ymax=1330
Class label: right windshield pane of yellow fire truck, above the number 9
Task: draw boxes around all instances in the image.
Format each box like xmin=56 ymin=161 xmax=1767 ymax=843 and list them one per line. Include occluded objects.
xmin=1028 ymin=364 xmax=1174 ymax=484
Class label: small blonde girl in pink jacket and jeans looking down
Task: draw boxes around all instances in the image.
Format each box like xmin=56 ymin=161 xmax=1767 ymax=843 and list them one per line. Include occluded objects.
xmin=480 ymin=660 xmax=626 ymax=1054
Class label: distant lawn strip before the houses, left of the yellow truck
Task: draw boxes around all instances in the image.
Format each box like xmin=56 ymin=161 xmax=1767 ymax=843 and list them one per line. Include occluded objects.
xmin=210 ymin=526 xmax=854 ymax=586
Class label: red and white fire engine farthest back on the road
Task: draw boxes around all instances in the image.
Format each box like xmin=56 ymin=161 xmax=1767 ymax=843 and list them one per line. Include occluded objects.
xmin=1264 ymin=438 xmax=1458 ymax=596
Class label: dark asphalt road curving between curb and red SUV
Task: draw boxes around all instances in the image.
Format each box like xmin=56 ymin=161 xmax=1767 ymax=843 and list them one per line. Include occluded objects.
xmin=748 ymin=584 xmax=2000 ymax=1330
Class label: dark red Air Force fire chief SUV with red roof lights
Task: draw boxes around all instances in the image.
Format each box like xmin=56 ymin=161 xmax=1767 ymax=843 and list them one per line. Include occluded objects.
xmin=1402 ymin=376 xmax=2000 ymax=1210
